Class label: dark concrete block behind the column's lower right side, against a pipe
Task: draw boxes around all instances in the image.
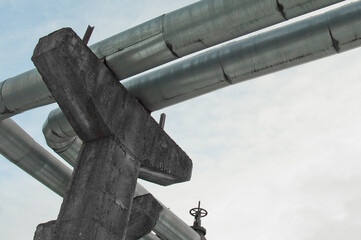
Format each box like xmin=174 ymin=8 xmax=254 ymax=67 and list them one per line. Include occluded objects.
xmin=125 ymin=194 xmax=163 ymax=240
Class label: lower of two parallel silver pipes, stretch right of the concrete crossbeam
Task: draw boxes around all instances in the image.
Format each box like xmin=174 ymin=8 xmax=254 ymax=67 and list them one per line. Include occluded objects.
xmin=123 ymin=1 xmax=361 ymax=111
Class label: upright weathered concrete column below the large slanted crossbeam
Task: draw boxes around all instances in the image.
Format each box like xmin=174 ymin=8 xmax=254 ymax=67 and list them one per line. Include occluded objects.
xmin=52 ymin=137 xmax=139 ymax=240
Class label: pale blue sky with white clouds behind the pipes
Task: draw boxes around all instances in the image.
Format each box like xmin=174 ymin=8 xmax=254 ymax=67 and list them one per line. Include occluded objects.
xmin=0 ymin=0 xmax=361 ymax=240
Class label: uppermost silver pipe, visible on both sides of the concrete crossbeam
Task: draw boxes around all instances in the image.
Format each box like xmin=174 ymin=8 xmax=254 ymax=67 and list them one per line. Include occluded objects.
xmin=0 ymin=0 xmax=343 ymax=119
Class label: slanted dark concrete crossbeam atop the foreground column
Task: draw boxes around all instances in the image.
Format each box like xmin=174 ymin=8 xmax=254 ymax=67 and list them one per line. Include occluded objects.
xmin=32 ymin=28 xmax=192 ymax=185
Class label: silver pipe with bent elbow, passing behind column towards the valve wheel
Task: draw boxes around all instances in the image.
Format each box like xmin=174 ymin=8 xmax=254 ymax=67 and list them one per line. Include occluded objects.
xmin=43 ymin=109 xmax=200 ymax=240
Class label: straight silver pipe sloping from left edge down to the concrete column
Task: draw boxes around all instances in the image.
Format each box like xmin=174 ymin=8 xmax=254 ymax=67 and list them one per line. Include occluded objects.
xmin=0 ymin=118 xmax=72 ymax=196
